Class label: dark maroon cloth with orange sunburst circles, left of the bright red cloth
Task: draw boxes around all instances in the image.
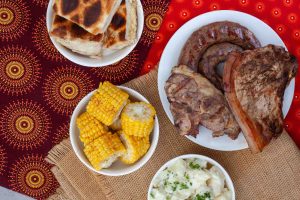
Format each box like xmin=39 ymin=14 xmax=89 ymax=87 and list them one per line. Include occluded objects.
xmin=0 ymin=0 xmax=169 ymax=199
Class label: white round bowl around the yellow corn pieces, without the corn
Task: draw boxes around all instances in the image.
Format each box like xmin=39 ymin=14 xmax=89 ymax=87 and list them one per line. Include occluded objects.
xmin=70 ymin=86 xmax=159 ymax=176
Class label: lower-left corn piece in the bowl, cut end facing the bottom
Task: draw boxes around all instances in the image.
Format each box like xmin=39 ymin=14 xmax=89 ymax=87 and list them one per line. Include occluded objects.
xmin=84 ymin=132 xmax=126 ymax=170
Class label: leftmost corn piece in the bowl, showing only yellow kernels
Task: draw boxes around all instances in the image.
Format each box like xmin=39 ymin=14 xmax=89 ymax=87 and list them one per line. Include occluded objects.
xmin=76 ymin=112 xmax=108 ymax=145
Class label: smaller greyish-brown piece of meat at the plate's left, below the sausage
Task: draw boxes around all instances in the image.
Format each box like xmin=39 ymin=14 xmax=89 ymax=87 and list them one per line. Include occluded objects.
xmin=165 ymin=65 xmax=240 ymax=139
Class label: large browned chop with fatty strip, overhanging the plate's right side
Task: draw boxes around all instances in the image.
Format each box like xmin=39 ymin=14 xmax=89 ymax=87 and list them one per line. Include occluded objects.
xmin=224 ymin=45 xmax=298 ymax=153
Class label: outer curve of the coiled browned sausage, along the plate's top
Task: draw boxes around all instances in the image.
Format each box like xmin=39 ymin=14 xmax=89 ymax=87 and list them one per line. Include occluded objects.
xmin=178 ymin=21 xmax=260 ymax=71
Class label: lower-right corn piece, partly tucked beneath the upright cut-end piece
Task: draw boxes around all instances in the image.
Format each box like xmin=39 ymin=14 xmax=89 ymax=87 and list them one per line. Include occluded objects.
xmin=119 ymin=131 xmax=150 ymax=164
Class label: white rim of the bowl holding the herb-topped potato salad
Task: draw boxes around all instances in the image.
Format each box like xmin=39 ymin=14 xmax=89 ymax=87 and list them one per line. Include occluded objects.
xmin=147 ymin=154 xmax=235 ymax=200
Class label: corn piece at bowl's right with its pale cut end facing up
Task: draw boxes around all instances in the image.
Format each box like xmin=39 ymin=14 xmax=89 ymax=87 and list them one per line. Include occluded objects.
xmin=121 ymin=102 xmax=156 ymax=137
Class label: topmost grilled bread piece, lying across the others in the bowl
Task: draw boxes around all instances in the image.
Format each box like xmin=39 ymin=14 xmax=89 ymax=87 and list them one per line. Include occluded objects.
xmin=53 ymin=0 xmax=122 ymax=35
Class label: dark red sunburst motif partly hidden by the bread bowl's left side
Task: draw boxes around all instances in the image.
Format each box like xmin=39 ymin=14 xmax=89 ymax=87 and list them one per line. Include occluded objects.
xmin=32 ymin=16 xmax=65 ymax=62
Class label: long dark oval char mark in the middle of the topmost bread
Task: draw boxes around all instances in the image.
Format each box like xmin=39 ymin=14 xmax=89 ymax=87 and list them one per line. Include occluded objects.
xmin=83 ymin=1 xmax=101 ymax=27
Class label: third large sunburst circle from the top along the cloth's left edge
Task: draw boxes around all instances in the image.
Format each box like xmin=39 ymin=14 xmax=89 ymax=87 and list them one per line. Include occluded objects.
xmin=0 ymin=100 xmax=51 ymax=150
